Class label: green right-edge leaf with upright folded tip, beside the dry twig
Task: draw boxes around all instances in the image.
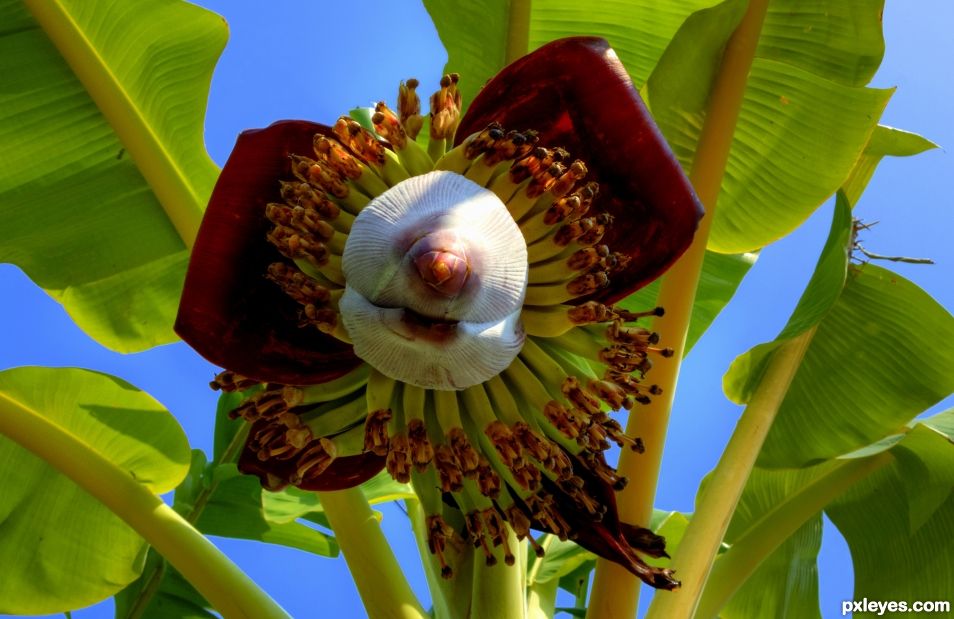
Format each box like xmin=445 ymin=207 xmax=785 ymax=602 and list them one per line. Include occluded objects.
xmin=723 ymin=191 xmax=954 ymax=467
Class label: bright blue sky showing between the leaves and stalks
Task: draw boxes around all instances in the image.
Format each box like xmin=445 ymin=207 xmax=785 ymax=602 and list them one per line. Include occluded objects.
xmin=0 ymin=0 xmax=954 ymax=619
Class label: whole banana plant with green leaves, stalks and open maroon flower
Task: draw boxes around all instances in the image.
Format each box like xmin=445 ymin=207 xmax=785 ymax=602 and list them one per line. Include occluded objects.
xmin=0 ymin=0 xmax=954 ymax=619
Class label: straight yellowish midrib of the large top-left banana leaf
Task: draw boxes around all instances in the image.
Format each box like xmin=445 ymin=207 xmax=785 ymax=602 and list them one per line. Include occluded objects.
xmin=24 ymin=0 xmax=205 ymax=249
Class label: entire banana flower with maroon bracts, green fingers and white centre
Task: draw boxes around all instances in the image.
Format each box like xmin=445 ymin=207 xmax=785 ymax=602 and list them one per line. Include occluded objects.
xmin=176 ymin=38 xmax=702 ymax=588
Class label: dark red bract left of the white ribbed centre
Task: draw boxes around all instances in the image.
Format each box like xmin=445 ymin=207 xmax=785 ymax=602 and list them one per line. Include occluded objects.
xmin=176 ymin=121 xmax=361 ymax=385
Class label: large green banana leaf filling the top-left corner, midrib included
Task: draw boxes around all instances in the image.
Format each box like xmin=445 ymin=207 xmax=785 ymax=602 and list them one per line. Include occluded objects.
xmin=0 ymin=0 xmax=227 ymax=352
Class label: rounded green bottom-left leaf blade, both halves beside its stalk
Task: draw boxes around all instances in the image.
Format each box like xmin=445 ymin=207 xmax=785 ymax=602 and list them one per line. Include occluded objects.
xmin=0 ymin=367 xmax=189 ymax=614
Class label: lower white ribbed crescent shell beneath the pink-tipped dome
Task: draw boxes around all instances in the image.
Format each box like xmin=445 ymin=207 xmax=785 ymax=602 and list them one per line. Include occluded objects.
xmin=339 ymin=285 xmax=524 ymax=391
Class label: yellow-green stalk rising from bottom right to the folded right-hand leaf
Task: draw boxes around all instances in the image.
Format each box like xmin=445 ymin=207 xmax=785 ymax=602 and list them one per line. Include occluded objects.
xmin=646 ymin=327 xmax=815 ymax=619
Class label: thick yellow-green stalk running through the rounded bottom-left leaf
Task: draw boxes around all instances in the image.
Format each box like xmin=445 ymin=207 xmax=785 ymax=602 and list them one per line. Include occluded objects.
xmin=0 ymin=396 xmax=288 ymax=619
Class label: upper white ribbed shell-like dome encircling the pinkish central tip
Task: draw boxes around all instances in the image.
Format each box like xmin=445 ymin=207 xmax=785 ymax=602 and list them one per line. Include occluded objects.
xmin=342 ymin=171 xmax=528 ymax=323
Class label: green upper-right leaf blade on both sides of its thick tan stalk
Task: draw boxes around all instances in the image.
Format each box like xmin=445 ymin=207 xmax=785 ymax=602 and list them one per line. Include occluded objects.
xmin=645 ymin=0 xmax=891 ymax=253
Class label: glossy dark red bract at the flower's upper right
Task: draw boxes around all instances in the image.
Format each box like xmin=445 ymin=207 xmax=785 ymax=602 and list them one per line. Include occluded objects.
xmin=457 ymin=37 xmax=703 ymax=302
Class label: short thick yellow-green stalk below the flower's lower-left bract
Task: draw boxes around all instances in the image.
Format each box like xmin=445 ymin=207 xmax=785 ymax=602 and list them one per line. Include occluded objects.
xmin=318 ymin=488 xmax=428 ymax=619
